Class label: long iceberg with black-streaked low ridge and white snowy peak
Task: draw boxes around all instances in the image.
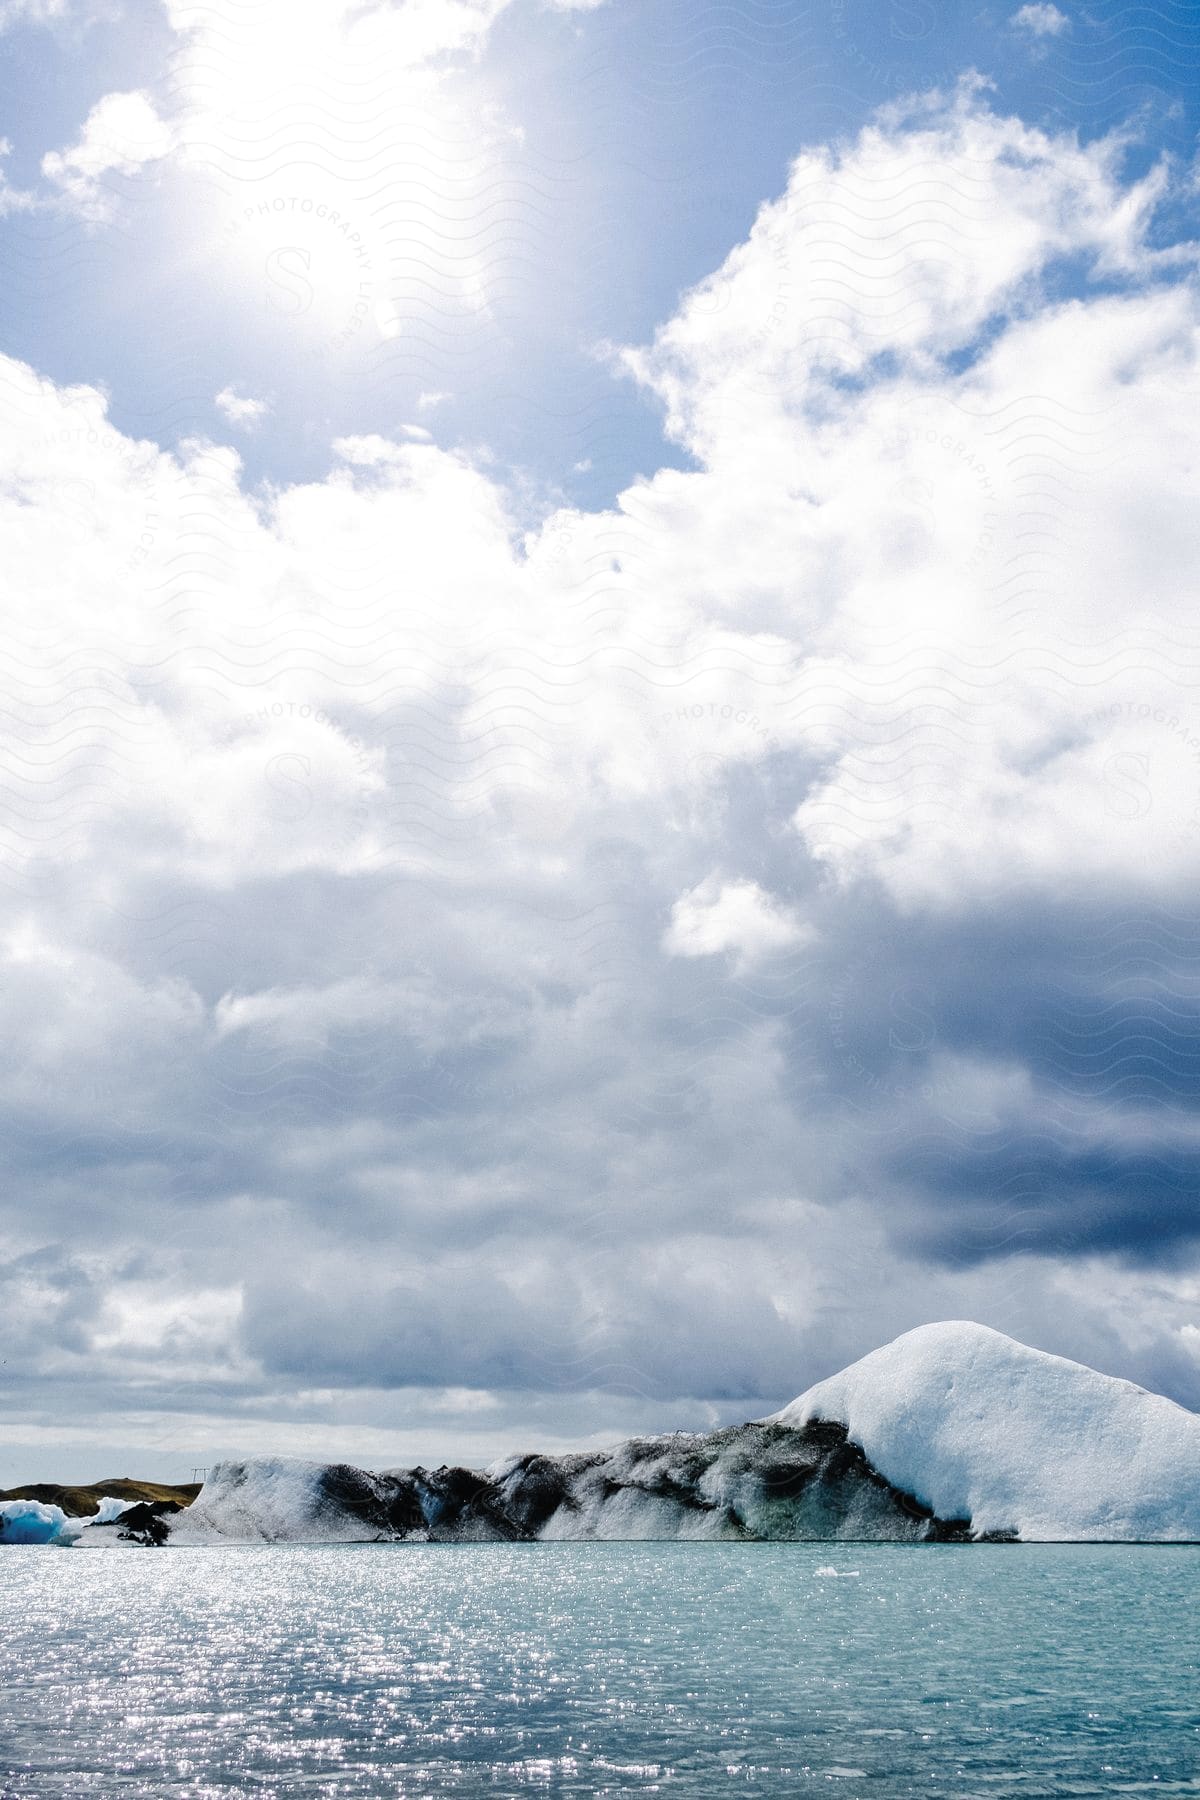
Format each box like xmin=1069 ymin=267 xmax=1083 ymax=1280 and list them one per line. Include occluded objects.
xmin=169 ymin=1323 xmax=1200 ymax=1544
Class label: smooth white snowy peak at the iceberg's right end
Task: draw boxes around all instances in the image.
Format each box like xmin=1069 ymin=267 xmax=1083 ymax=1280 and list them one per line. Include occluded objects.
xmin=774 ymin=1319 xmax=1200 ymax=1541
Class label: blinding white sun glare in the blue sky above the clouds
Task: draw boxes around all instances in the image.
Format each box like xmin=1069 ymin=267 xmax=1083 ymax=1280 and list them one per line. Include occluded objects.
xmin=175 ymin=0 xmax=516 ymax=356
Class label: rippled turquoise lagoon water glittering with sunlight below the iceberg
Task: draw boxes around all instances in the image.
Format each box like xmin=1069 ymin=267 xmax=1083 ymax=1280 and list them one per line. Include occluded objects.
xmin=0 ymin=1543 xmax=1200 ymax=1800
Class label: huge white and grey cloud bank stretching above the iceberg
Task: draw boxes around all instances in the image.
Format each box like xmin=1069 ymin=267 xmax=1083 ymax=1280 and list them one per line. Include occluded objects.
xmin=0 ymin=81 xmax=1200 ymax=1476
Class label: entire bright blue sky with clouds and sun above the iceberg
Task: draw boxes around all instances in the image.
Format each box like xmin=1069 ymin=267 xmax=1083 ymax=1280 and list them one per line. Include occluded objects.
xmin=0 ymin=0 xmax=1200 ymax=1487
